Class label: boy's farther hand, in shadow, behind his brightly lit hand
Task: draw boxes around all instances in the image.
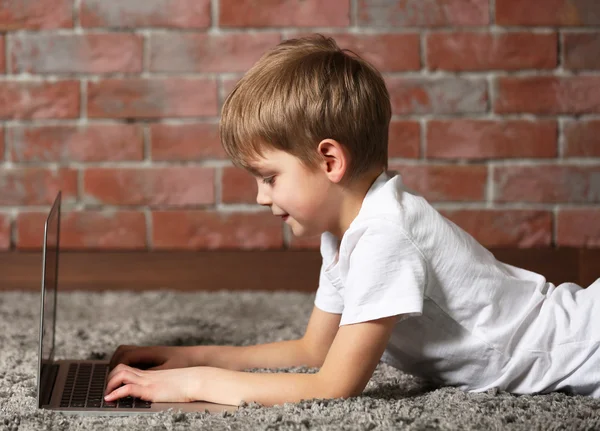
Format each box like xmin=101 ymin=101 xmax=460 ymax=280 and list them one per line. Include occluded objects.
xmin=110 ymin=345 xmax=194 ymax=370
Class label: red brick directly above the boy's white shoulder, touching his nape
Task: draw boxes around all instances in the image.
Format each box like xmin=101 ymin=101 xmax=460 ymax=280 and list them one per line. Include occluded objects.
xmin=389 ymin=163 xmax=488 ymax=202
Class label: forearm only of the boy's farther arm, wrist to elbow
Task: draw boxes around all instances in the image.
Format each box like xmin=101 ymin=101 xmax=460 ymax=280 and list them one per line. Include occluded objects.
xmin=197 ymin=339 xmax=321 ymax=371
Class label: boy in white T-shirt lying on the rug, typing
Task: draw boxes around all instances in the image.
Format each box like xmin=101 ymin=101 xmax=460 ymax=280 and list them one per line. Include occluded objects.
xmin=106 ymin=35 xmax=600 ymax=406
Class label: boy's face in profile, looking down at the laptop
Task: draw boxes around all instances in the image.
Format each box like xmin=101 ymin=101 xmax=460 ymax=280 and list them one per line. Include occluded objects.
xmin=246 ymin=150 xmax=335 ymax=236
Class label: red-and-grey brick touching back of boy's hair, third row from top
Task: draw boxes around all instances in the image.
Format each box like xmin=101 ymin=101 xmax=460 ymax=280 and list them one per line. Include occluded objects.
xmin=386 ymin=77 xmax=488 ymax=115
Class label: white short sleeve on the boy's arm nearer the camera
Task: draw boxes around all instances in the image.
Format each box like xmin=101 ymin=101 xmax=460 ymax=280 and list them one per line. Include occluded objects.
xmin=340 ymin=223 xmax=427 ymax=326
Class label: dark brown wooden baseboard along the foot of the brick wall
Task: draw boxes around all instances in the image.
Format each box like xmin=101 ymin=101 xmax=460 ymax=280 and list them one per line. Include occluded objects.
xmin=0 ymin=248 xmax=600 ymax=292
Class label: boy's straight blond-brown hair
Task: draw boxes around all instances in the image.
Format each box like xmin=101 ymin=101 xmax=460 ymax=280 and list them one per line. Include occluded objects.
xmin=219 ymin=34 xmax=391 ymax=180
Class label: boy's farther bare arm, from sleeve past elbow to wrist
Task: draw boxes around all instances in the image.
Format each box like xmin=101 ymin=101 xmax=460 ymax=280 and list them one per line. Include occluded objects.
xmin=198 ymin=307 xmax=341 ymax=371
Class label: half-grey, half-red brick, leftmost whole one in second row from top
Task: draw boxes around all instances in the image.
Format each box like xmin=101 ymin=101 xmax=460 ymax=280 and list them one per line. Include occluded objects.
xmin=10 ymin=33 xmax=143 ymax=73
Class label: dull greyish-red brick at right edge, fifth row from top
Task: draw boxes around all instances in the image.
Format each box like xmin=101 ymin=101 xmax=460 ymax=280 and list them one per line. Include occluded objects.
xmin=493 ymin=165 xmax=600 ymax=204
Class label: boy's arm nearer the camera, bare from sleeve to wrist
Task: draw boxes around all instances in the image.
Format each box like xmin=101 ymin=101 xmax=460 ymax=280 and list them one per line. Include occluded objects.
xmin=194 ymin=316 xmax=397 ymax=406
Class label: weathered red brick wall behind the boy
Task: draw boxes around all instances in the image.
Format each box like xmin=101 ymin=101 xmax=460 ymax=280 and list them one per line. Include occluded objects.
xmin=0 ymin=0 xmax=600 ymax=250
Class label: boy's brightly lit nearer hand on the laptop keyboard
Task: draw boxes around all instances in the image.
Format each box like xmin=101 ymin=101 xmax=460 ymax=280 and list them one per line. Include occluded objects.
xmin=104 ymin=364 xmax=200 ymax=403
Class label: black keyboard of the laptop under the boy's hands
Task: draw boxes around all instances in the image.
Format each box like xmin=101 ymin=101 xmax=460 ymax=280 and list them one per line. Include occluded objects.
xmin=60 ymin=363 xmax=152 ymax=409
